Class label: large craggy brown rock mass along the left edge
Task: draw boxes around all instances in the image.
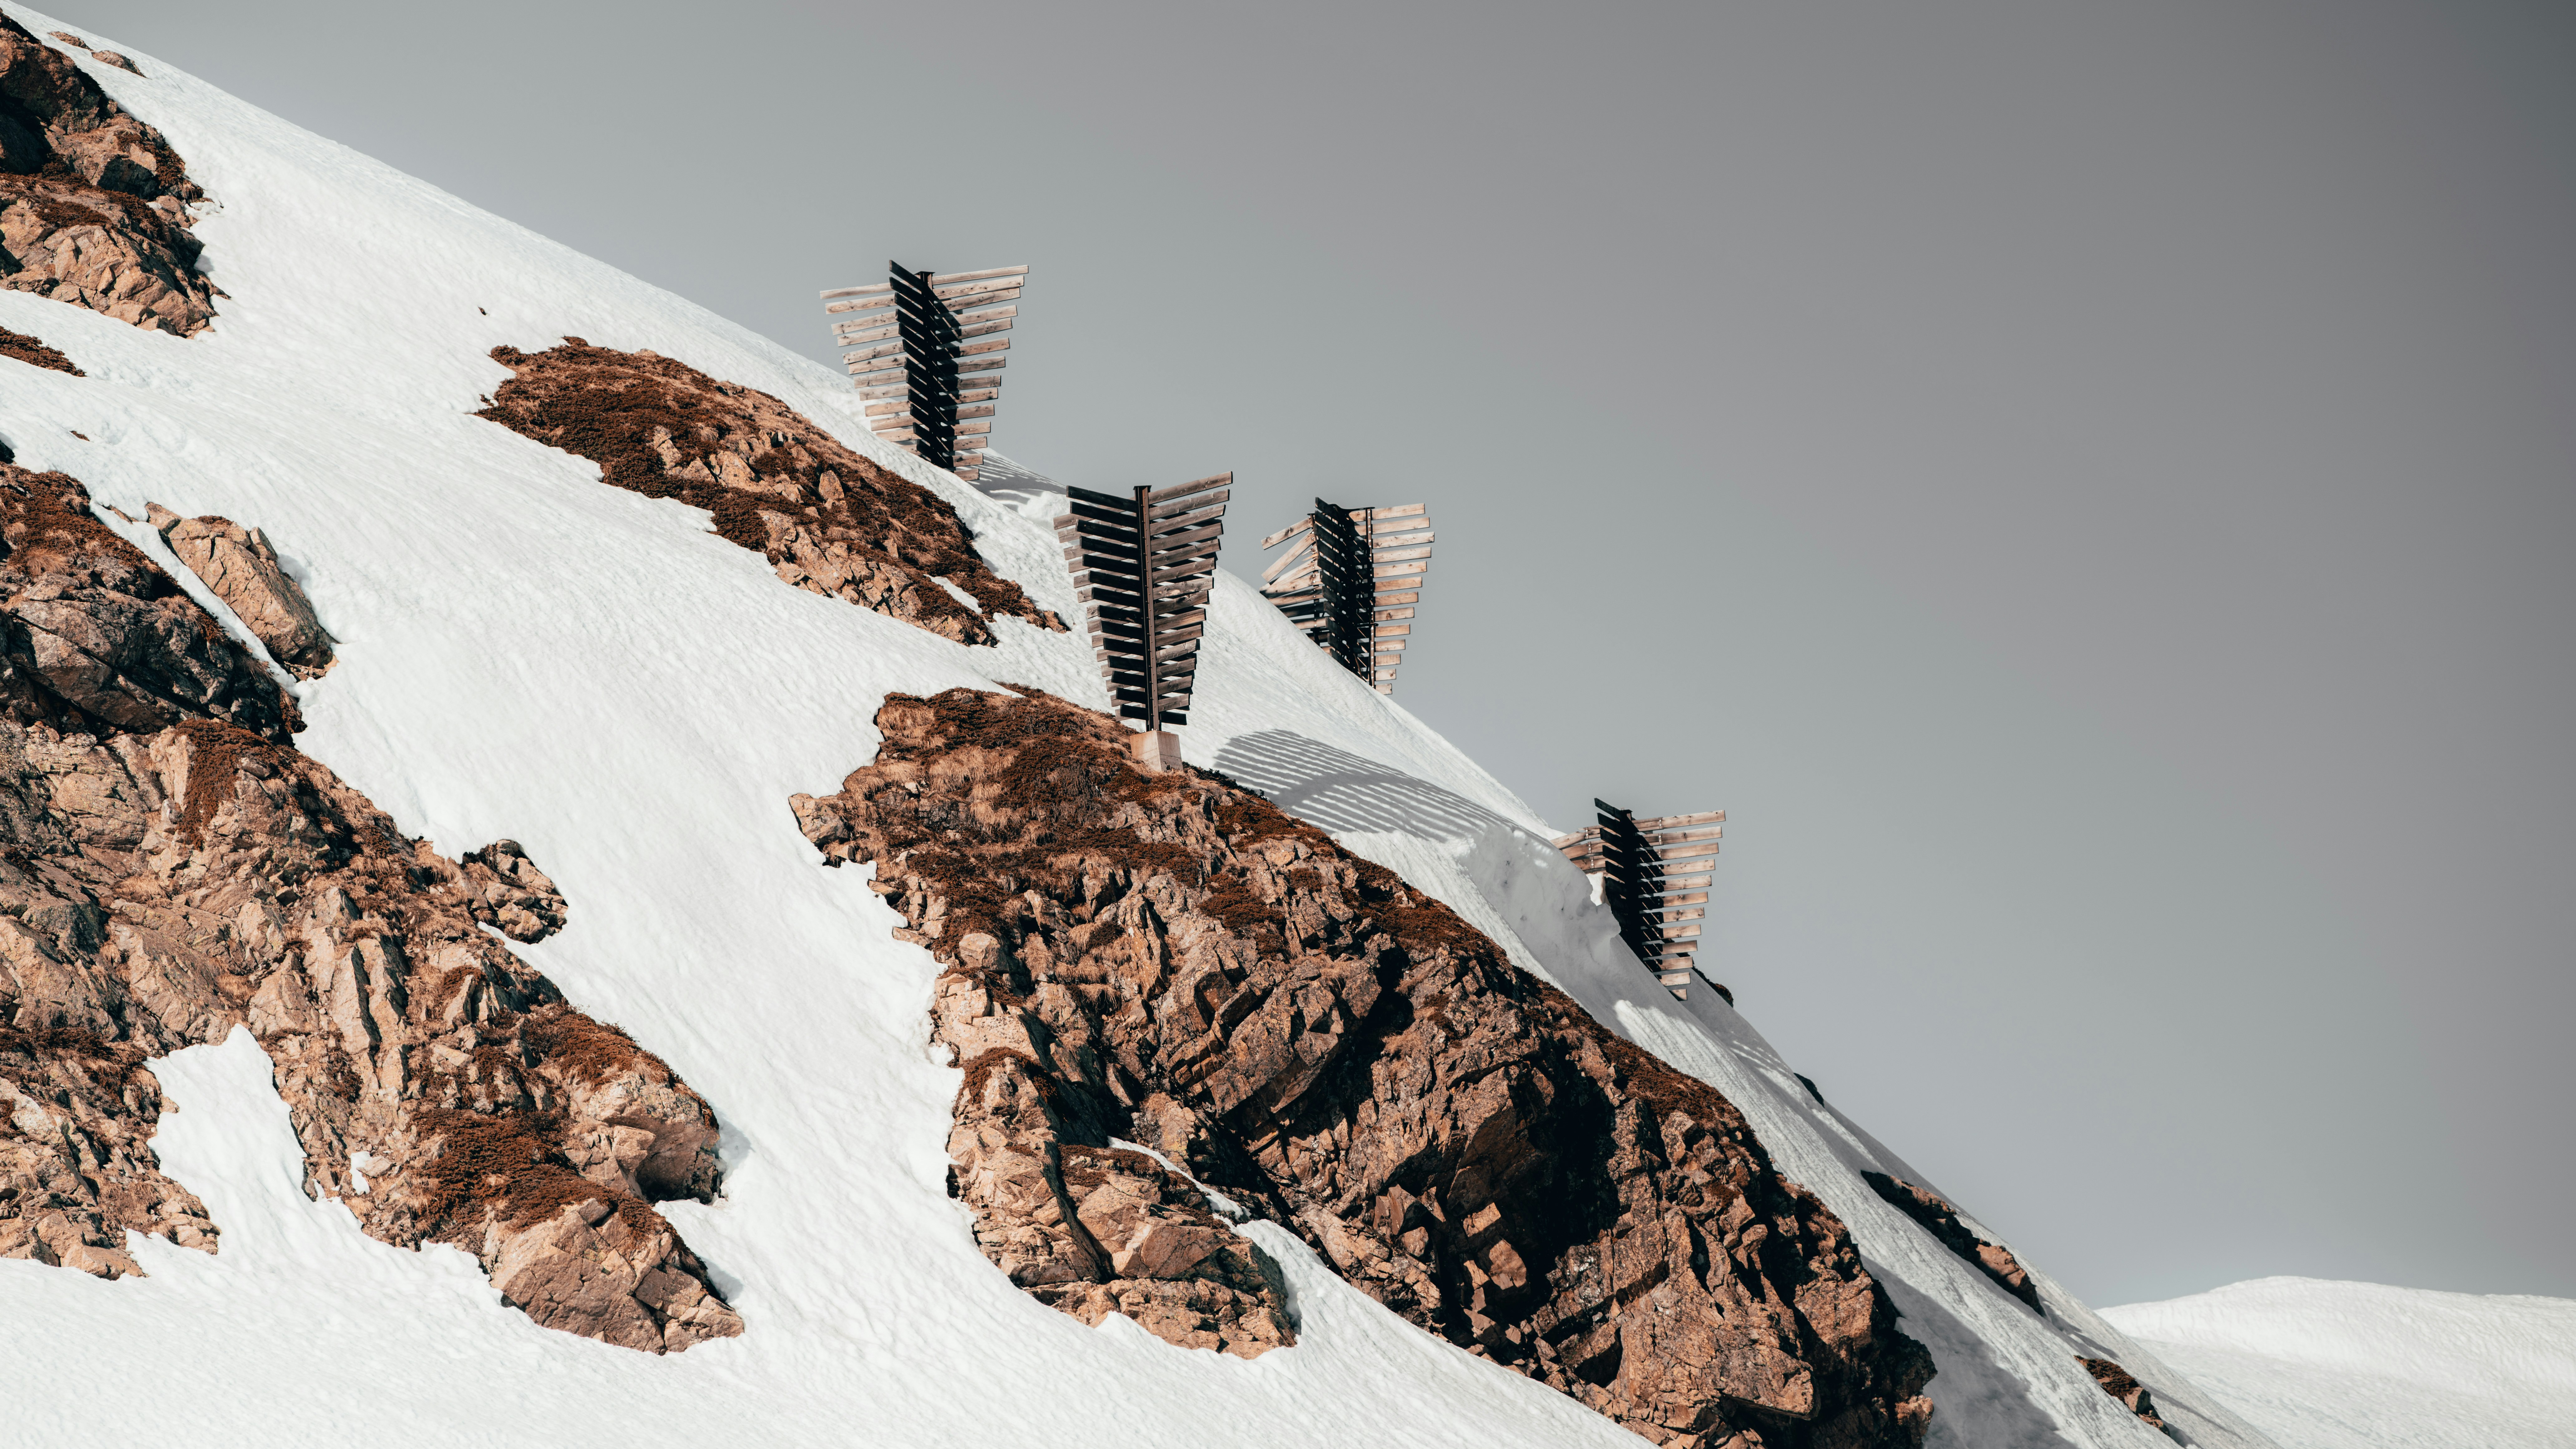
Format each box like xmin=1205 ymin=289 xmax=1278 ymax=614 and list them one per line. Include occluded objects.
xmin=0 ymin=467 xmax=742 ymax=1351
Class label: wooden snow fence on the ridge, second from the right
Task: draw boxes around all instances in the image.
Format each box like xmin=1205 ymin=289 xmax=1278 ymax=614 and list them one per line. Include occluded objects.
xmin=1262 ymin=498 xmax=1432 ymax=694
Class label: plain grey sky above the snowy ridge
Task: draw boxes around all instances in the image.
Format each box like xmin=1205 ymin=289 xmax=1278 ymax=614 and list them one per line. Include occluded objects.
xmin=57 ymin=0 xmax=2576 ymax=1302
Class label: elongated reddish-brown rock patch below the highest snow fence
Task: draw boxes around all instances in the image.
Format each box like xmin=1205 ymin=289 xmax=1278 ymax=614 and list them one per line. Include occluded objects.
xmin=476 ymin=338 xmax=1064 ymax=645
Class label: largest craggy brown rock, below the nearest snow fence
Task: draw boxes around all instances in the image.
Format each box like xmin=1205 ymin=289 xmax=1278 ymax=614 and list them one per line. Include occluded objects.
xmin=791 ymin=691 xmax=1932 ymax=1449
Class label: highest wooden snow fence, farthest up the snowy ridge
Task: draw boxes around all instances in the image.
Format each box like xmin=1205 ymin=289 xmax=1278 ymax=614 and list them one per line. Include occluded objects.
xmin=822 ymin=263 xmax=1028 ymax=482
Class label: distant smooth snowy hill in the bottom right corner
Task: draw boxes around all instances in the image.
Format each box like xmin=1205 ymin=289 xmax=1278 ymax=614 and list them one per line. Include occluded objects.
xmin=2102 ymin=1279 xmax=2576 ymax=1449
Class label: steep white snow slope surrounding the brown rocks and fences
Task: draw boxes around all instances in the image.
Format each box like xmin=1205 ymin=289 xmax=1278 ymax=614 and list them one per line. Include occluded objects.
xmin=0 ymin=5 xmax=2270 ymax=1449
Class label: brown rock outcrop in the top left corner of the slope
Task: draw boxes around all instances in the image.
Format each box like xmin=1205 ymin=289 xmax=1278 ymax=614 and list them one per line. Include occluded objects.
xmin=0 ymin=16 xmax=214 ymax=338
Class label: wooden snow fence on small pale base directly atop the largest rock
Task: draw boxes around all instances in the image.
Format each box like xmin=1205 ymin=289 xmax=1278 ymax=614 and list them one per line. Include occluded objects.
xmin=1056 ymin=472 xmax=1234 ymax=732
